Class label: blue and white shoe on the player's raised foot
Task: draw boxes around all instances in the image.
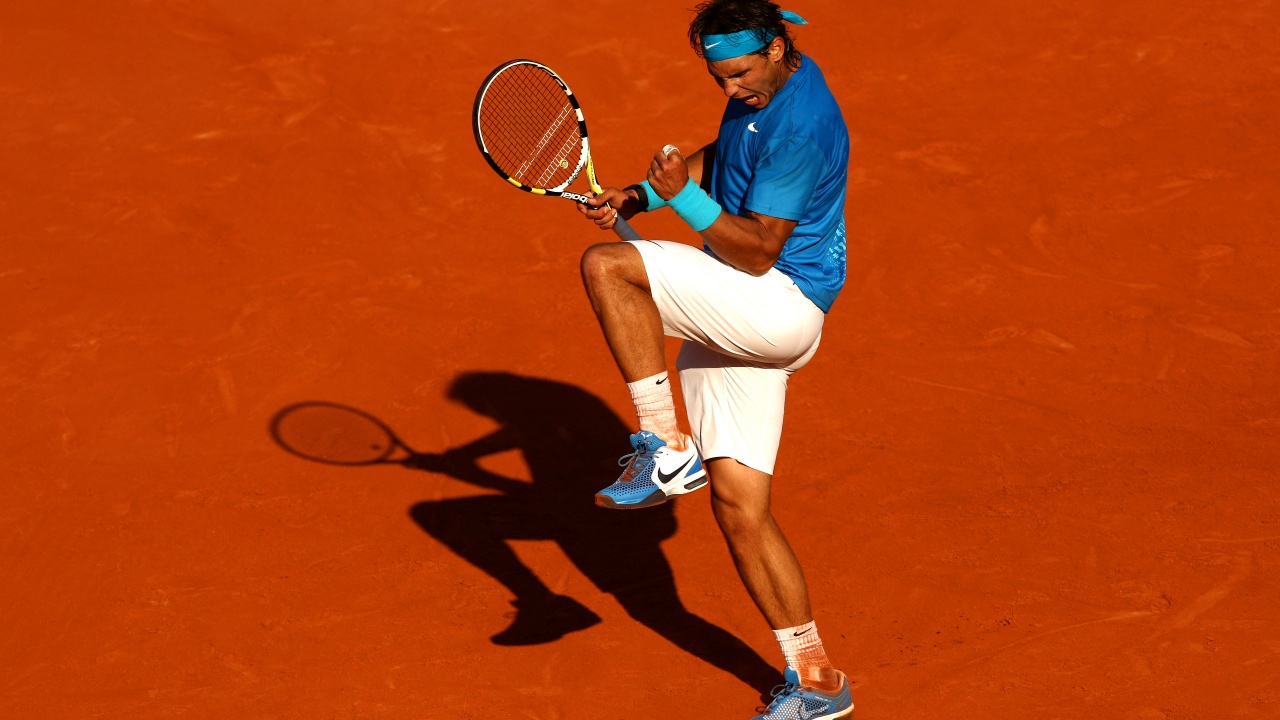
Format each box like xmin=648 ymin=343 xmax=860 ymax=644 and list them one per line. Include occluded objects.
xmin=595 ymin=430 xmax=707 ymax=510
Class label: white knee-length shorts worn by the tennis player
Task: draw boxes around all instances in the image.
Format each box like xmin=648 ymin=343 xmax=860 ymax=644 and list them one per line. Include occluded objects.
xmin=631 ymin=240 xmax=826 ymax=475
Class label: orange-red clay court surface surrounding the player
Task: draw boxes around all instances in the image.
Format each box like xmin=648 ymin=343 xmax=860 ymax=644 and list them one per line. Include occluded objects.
xmin=0 ymin=0 xmax=1280 ymax=720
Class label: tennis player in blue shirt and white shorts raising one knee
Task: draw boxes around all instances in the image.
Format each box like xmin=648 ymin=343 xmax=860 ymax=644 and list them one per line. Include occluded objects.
xmin=579 ymin=0 xmax=854 ymax=720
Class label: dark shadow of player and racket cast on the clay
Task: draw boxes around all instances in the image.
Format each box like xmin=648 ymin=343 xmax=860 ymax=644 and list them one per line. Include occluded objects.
xmin=264 ymin=372 xmax=778 ymax=696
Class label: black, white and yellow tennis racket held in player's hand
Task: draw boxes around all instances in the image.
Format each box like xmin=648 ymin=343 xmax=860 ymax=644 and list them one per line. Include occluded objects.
xmin=471 ymin=60 xmax=640 ymax=240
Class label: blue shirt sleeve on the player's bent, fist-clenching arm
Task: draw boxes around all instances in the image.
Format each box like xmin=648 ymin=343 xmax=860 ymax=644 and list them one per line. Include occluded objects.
xmin=744 ymin=136 xmax=827 ymax=222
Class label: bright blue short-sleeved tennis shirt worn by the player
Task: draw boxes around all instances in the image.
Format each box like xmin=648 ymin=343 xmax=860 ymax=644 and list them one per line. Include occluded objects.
xmin=707 ymin=58 xmax=849 ymax=313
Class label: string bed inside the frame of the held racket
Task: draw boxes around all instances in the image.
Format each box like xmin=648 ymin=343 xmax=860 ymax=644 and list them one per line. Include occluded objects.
xmin=480 ymin=65 xmax=582 ymax=188
